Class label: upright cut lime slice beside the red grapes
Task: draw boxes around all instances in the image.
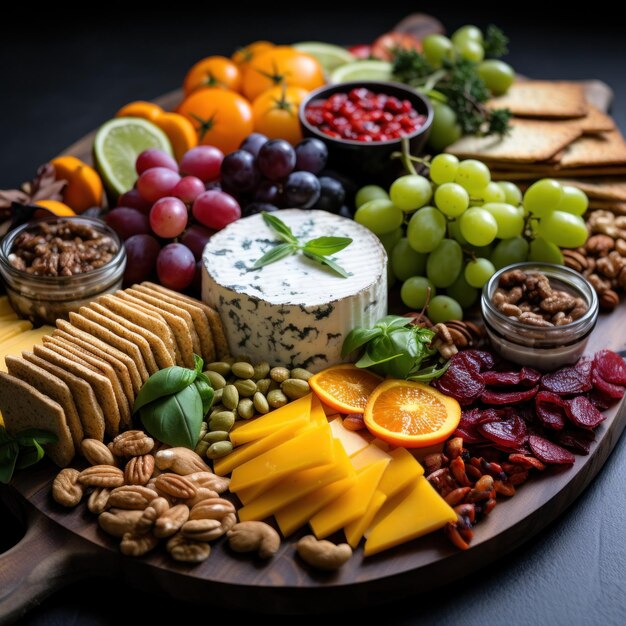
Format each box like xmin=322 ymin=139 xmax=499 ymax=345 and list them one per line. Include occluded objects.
xmin=93 ymin=117 xmax=173 ymax=195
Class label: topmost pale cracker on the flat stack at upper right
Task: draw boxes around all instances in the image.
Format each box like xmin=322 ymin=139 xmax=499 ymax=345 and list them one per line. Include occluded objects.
xmin=487 ymin=80 xmax=588 ymax=119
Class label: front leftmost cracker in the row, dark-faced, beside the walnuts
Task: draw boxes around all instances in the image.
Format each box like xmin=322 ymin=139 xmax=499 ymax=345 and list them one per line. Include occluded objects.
xmin=0 ymin=372 xmax=75 ymax=467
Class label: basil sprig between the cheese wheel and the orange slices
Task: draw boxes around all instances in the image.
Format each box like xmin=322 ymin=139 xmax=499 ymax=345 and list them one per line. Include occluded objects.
xmin=341 ymin=315 xmax=447 ymax=382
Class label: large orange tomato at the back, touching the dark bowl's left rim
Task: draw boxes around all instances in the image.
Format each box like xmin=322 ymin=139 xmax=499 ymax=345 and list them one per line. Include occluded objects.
xmin=243 ymin=46 xmax=324 ymax=100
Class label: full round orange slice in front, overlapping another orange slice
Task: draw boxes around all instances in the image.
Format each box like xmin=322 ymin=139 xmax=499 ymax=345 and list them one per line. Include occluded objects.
xmin=364 ymin=380 xmax=461 ymax=448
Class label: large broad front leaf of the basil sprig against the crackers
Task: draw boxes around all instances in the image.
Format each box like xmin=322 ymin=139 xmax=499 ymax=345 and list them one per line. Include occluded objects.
xmin=139 ymin=385 xmax=204 ymax=450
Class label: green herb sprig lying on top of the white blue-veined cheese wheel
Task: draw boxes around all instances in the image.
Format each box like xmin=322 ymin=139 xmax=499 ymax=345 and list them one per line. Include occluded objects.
xmin=252 ymin=211 xmax=352 ymax=278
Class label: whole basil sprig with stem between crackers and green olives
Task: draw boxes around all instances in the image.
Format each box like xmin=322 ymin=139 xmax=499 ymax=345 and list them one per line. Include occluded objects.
xmin=133 ymin=354 xmax=214 ymax=449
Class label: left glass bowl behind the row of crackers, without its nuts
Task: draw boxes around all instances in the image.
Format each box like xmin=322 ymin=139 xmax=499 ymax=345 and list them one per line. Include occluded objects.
xmin=0 ymin=217 xmax=126 ymax=325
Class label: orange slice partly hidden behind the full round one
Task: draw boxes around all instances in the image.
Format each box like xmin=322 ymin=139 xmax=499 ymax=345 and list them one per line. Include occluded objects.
xmin=309 ymin=363 xmax=382 ymax=413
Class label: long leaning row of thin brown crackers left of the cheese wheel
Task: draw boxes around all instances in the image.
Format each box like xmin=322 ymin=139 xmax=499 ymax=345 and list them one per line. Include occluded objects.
xmin=0 ymin=282 xmax=229 ymax=467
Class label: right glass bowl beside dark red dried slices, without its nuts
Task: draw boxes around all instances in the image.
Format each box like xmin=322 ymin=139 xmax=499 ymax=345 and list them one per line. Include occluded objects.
xmin=480 ymin=263 xmax=598 ymax=372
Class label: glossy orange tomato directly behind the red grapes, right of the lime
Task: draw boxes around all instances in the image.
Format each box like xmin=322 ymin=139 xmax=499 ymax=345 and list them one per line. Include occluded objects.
xmin=178 ymin=87 xmax=254 ymax=154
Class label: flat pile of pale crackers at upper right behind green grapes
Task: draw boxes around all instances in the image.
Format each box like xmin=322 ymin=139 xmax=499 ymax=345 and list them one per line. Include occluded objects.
xmin=447 ymin=80 xmax=626 ymax=214
